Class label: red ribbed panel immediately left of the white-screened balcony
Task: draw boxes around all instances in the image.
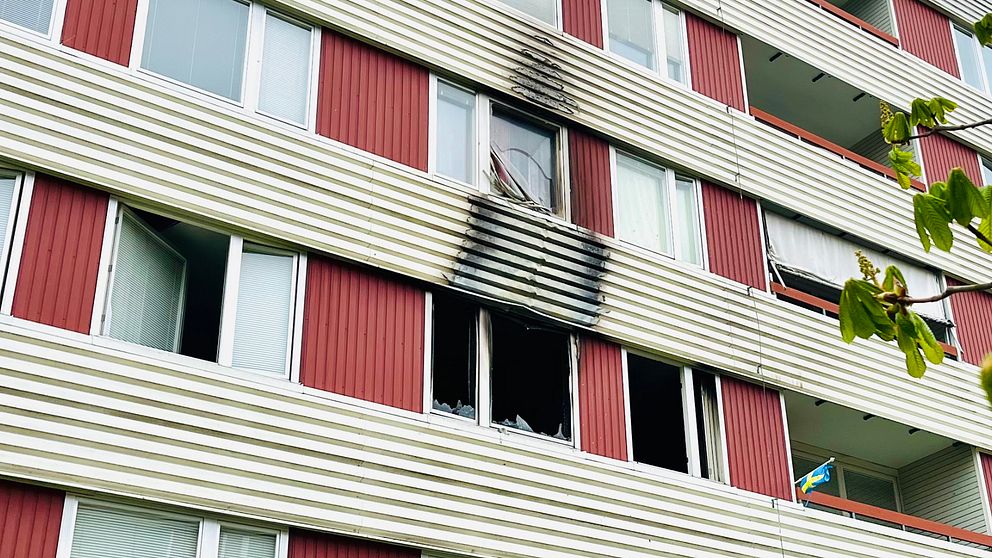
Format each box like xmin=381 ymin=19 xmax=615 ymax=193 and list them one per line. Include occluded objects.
xmin=702 ymin=182 xmax=767 ymax=290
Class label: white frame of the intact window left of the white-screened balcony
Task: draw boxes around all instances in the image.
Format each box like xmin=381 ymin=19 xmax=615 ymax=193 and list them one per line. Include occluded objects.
xmin=610 ymin=145 xmax=709 ymax=270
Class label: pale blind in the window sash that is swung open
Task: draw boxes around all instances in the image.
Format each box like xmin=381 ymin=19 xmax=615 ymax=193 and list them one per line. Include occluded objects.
xmin=108 ymin=212 xmax=186 ymax=351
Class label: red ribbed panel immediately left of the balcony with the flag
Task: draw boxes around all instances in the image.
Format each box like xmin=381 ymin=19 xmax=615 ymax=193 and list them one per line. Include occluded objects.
xmin=720 ymin=377 xmax=793 ymax=500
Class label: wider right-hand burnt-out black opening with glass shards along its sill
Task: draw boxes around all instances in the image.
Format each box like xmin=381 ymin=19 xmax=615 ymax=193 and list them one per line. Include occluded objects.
xmin=490 ymin=314 xmax=572 ymax=440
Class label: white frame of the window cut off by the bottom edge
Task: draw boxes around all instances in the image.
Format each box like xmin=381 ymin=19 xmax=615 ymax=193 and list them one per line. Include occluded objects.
xmin=55 ymin=494 xmax=289 ymax=558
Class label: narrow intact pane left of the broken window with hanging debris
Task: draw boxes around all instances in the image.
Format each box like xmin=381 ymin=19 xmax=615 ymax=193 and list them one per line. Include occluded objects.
xmin=436 ymin=81 xmax=475 ymax=183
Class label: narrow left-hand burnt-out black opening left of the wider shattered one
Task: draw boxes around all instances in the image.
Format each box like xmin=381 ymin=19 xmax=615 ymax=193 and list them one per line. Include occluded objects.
xmin=431 ymin=295 xmax=479 ymax=419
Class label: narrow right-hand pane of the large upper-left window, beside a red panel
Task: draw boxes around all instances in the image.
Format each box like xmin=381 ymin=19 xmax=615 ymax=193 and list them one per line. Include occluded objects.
xmin=258 ymin=13 xmax=312 ymax=125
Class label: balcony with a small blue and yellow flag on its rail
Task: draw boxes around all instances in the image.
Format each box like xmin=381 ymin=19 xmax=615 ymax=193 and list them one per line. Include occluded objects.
xmin=785 ymin=393 xmax=992 ymax=550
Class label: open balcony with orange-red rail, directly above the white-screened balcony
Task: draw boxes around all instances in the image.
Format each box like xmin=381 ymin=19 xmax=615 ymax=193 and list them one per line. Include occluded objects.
xmin=741 ymin=36 xmax=924 ymax=190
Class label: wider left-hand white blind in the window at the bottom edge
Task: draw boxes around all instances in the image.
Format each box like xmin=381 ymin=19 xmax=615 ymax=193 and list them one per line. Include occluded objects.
xmin=69 ymin=505 xmax=200 ymax=558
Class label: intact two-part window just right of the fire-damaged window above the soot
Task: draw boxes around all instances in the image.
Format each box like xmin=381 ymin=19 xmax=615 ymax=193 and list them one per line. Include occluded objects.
xmin=616 ymin=152 xmax=703 ymax=265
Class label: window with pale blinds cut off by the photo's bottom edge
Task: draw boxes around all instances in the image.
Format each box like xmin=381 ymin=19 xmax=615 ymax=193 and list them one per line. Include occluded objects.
xmin=62 ymin=496 xmax=287 ymax=558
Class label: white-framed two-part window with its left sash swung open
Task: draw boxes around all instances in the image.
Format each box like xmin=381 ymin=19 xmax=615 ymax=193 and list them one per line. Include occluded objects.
xmin=102 ymin=207 xmax=300 ymax=376
